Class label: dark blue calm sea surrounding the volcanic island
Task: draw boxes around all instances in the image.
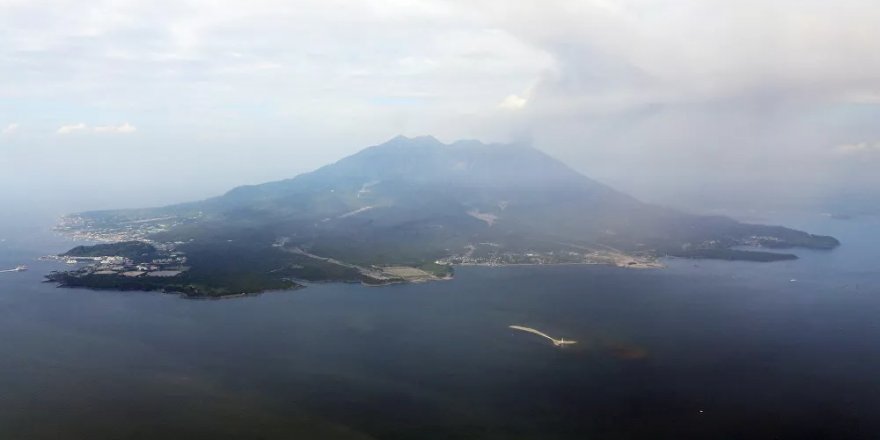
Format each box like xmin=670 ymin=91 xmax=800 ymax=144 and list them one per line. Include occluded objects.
xmin=0 ymin=212 xmax=880 ymax=439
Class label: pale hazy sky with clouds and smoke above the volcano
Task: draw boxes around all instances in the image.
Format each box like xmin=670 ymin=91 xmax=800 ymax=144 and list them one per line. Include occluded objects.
xmin=0 ymin=0 xmax=880 ymax=210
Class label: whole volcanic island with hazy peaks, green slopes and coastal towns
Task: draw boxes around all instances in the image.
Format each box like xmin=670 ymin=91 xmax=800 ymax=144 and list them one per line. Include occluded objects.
xmin=48 ymin=136 xmax=839 ymax=297
